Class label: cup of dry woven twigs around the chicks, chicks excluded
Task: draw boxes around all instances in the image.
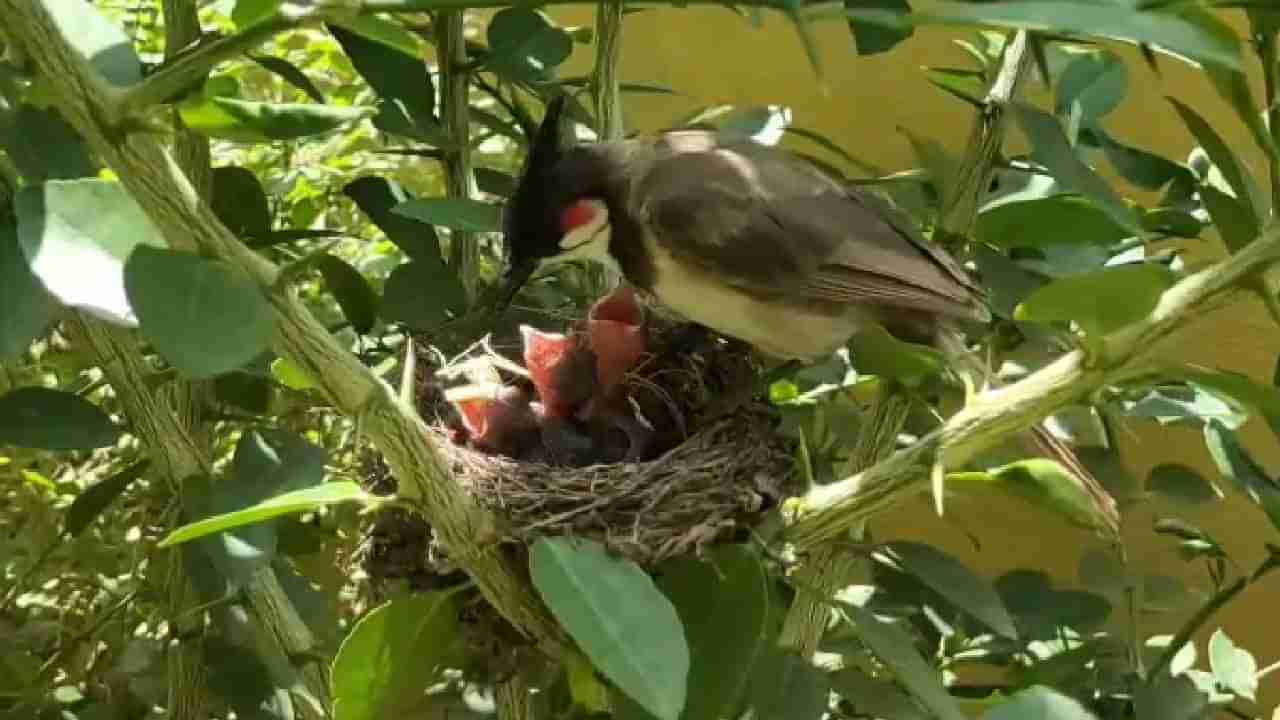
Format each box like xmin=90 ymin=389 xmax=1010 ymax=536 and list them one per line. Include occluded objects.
xmin=366 ymin=297 xmax=795 ymax=585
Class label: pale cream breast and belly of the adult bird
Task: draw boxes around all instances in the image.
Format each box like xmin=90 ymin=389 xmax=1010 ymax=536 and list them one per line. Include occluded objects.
xmin=646 ymin=234 xmax=869 ymax=360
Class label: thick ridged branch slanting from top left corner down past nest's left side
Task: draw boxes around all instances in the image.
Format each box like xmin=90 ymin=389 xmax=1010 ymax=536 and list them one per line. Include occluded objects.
xmin=0 ymin=0 xmax=567 ymax=653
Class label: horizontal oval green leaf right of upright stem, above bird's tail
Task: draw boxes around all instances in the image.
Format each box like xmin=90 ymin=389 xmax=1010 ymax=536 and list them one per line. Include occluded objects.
xmin=974 ymin=195 xmax=1133 ymax=249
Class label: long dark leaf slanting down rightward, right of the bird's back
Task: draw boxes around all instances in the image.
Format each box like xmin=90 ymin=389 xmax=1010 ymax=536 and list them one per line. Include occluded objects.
xmin=1011 ymin=103 xmax=1142 ymax=233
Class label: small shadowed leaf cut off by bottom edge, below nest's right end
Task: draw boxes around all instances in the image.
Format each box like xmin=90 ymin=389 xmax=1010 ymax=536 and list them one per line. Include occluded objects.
xmin=742 ymin=648 xmax=831 ymax=720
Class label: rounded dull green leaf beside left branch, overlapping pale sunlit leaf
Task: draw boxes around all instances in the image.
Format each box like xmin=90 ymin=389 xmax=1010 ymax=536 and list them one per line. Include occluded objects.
xmin=124 ymin=246 xmax=275 ymax=378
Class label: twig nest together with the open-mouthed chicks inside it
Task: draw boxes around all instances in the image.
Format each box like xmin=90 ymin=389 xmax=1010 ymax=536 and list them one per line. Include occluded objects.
xmin=371 ymin=287 xmax=795 ymax=565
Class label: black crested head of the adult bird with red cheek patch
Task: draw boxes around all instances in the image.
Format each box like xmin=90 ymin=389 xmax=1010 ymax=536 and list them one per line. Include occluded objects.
xmin=498 ymin=95 xmax=612 ymax=311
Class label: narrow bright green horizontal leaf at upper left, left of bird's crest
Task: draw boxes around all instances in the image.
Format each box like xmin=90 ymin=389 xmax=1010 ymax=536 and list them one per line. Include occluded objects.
xmin=178 ymin=95 xmax=378 ymax=143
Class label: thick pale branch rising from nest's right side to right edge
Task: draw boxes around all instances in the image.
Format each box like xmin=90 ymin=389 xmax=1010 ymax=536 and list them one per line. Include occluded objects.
xmin=786 ymin=224 xmax=1280 ymax=548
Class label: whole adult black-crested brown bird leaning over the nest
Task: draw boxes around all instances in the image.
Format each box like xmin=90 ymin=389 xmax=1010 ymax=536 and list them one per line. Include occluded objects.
xmin=495 ymin=95 xmax=1119 ymax=525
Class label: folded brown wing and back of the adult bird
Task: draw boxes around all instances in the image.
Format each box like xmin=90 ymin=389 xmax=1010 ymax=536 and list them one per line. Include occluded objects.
xmin=631 ymin=131 xmax=989 ymax=320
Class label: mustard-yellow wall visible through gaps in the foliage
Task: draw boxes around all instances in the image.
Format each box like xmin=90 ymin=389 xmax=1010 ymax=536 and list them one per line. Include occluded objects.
xmin=540 ymin=6 xmax=1280 ymax=707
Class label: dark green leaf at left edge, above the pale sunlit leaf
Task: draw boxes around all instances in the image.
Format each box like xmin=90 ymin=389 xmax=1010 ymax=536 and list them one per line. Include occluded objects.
xmin=0 ymin=102 xmax=97 ymax=184
